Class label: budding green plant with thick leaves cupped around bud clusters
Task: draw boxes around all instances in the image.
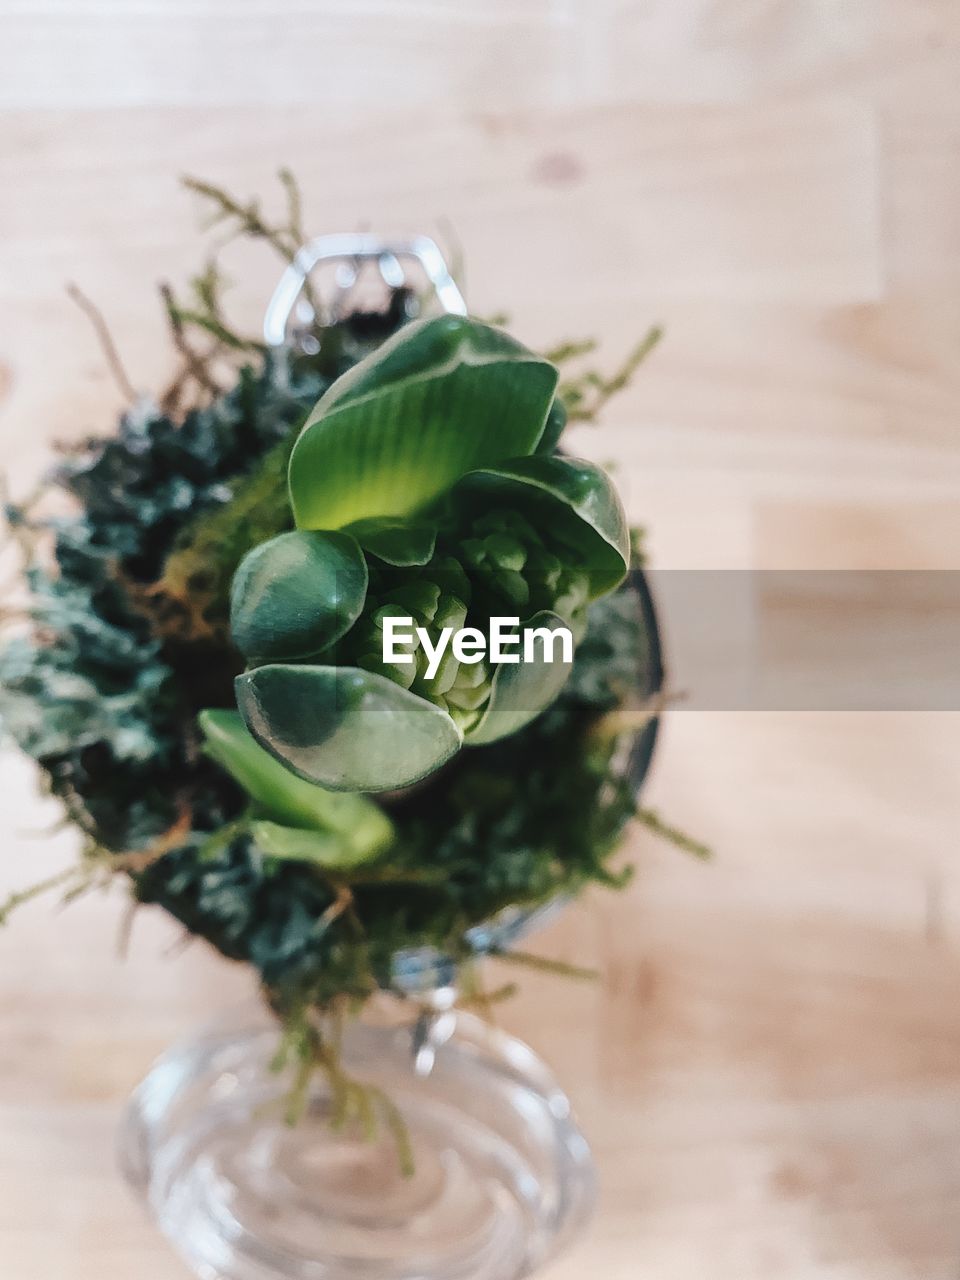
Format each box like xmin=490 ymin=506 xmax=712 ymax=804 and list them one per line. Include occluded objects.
xmin=230 ymin=316 xmax=630 ymax=791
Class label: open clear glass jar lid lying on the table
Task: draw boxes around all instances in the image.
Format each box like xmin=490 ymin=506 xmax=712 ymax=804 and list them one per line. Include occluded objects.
xmin=122 ymin=992 xmax=595 ymax=1280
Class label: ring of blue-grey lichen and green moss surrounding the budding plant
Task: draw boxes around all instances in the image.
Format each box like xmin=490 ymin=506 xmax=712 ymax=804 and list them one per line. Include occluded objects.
xmin=0 ymin=332 xmax=653 ymax=1007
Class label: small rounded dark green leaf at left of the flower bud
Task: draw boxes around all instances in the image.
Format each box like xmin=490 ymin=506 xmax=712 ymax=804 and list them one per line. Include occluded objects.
xmin=230 ymin=530 xmax=367 ymax=662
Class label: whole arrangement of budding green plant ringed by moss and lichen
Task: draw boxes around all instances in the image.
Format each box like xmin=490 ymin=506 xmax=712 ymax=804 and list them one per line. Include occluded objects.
xmin=0 ymin=174 xmax=700 ymax=1152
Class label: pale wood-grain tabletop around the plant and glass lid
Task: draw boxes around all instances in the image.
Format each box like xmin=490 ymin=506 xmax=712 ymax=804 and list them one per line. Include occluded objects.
xmin=0 ymin=0 xmax=960 ymax=1280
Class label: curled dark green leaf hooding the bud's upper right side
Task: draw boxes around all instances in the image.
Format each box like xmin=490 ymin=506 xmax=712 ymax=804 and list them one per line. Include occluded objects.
xmin=453 ymin=454 xmax=630 ymax=599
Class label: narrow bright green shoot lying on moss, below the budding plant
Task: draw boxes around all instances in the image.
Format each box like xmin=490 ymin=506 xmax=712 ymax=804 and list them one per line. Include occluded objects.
xmin=197 ymin=710 xmax=393 ymax=855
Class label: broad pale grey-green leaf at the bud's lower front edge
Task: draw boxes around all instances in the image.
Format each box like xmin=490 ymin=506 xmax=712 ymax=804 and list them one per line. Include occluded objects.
xmin=237 ymin=664 xmax=462 ymax=791
